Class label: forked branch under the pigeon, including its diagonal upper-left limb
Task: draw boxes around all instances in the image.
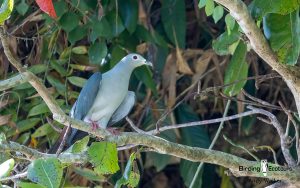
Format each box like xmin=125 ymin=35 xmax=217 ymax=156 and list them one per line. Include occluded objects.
xmin=0 ymin=24 xmax=300 ymax=182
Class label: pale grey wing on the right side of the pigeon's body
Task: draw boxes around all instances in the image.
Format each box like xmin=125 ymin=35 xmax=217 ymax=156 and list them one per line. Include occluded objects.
xmin=108 ymin=91 xmax=136 ymax=126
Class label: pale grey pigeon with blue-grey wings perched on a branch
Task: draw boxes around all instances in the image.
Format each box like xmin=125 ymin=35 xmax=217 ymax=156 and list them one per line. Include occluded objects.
xmin=49 ymin=54 xmax=152 ymax=153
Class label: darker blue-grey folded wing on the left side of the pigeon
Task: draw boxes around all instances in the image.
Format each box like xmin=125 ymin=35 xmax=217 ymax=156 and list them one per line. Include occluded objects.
xmin=73 ymin=72 xmax=102 ymax=120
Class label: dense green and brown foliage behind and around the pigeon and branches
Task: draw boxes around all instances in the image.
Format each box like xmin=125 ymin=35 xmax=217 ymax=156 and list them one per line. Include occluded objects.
xmin=0 ymin=0 xmax=300 ymax=187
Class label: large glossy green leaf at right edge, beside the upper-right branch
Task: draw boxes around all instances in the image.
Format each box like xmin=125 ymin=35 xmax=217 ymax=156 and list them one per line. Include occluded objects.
xmin=263 ymin=10 xmax=300 ymax=65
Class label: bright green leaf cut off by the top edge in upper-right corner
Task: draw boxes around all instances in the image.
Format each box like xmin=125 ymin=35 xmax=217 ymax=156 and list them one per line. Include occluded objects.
xmin=249 ymin=0 xmax=300 ymax=19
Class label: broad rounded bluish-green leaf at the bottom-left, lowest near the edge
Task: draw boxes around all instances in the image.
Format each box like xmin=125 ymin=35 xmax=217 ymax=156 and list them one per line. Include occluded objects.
xmin=27 ymin=158 xmax=63 ymax=188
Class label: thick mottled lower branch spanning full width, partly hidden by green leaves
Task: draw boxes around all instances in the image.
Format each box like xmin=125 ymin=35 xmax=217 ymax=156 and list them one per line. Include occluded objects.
xmin=0 ymin=140 xmax=300 ymax=182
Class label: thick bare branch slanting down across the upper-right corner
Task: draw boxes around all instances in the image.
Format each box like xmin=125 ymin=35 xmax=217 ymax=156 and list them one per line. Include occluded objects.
xmin=214 ymin=0 xmax=300 ymax=113
